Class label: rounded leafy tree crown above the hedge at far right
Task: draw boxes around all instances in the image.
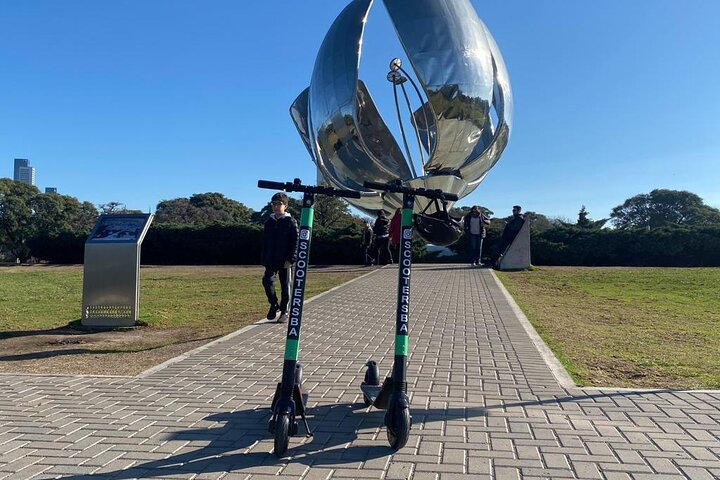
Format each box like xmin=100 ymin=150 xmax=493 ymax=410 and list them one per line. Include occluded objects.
xmin=610 ymin=189 xmax=720 ymax=229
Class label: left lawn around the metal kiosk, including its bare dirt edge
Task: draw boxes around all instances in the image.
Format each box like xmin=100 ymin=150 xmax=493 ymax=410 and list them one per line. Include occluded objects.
xmin=0 ymin=266 xmax=371 ymax=376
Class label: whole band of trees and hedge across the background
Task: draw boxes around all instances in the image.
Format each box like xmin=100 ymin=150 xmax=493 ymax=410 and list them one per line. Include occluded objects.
xmin=0 ymin=179 xmax=720 ymax=266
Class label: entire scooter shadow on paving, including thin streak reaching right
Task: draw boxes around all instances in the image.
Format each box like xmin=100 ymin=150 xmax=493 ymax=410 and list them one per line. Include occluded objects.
xmin=54 ymin=389 xmax=673 ymax=480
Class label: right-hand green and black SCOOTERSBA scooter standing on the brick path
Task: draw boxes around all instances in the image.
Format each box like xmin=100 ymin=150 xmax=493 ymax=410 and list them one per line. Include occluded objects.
xmin=360 ymin=180 xmax=458 ymax=450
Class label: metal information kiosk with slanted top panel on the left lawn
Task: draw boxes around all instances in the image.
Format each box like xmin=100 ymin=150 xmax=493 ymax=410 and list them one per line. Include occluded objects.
xmin=81 ymin=214 xmax=153 ymax=327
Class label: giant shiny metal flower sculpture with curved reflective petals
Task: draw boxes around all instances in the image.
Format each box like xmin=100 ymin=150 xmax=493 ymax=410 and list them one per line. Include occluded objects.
xmin=290 ymin=0 xmax=512 ymax=244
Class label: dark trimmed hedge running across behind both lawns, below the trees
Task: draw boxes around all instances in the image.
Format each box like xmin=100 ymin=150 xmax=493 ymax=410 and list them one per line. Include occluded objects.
xmin=28 ymin=224 xmax=720 ymax=267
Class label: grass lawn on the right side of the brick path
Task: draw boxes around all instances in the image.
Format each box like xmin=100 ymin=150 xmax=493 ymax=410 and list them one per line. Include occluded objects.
xmin=498 ymin=267 xmax=720 ymax=389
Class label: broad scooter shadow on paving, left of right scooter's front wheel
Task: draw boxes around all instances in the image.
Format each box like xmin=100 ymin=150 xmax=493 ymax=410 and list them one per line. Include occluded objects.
xmin=61 ymin=403 xmax=400 ymax=480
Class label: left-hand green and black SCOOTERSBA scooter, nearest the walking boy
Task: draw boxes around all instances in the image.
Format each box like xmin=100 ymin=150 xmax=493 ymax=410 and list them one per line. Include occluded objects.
xmin=258 ymin=178 xmax=360 ymax=457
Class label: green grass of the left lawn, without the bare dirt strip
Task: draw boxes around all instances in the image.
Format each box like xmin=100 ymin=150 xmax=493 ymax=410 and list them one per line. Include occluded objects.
xmin=0 ymin=266 xmax=367 ymax=332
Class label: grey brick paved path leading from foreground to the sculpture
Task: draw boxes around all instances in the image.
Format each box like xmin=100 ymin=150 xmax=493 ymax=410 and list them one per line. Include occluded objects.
xmin=0 ymin=265 xmax=720 ymax=480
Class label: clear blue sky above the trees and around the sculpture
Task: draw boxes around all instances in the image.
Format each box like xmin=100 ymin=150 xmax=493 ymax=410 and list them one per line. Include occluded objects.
xmin=0 ymin=0 xmax=720 ymax=219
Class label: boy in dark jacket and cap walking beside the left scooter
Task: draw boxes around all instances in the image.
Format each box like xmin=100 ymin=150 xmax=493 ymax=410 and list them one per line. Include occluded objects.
xmin=262 ymin=192 xmax=298 ymax=323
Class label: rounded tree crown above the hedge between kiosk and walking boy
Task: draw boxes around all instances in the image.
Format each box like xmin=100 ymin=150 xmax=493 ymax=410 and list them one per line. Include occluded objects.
xmin=155 ymin=193 xmax=252 ymax=225
